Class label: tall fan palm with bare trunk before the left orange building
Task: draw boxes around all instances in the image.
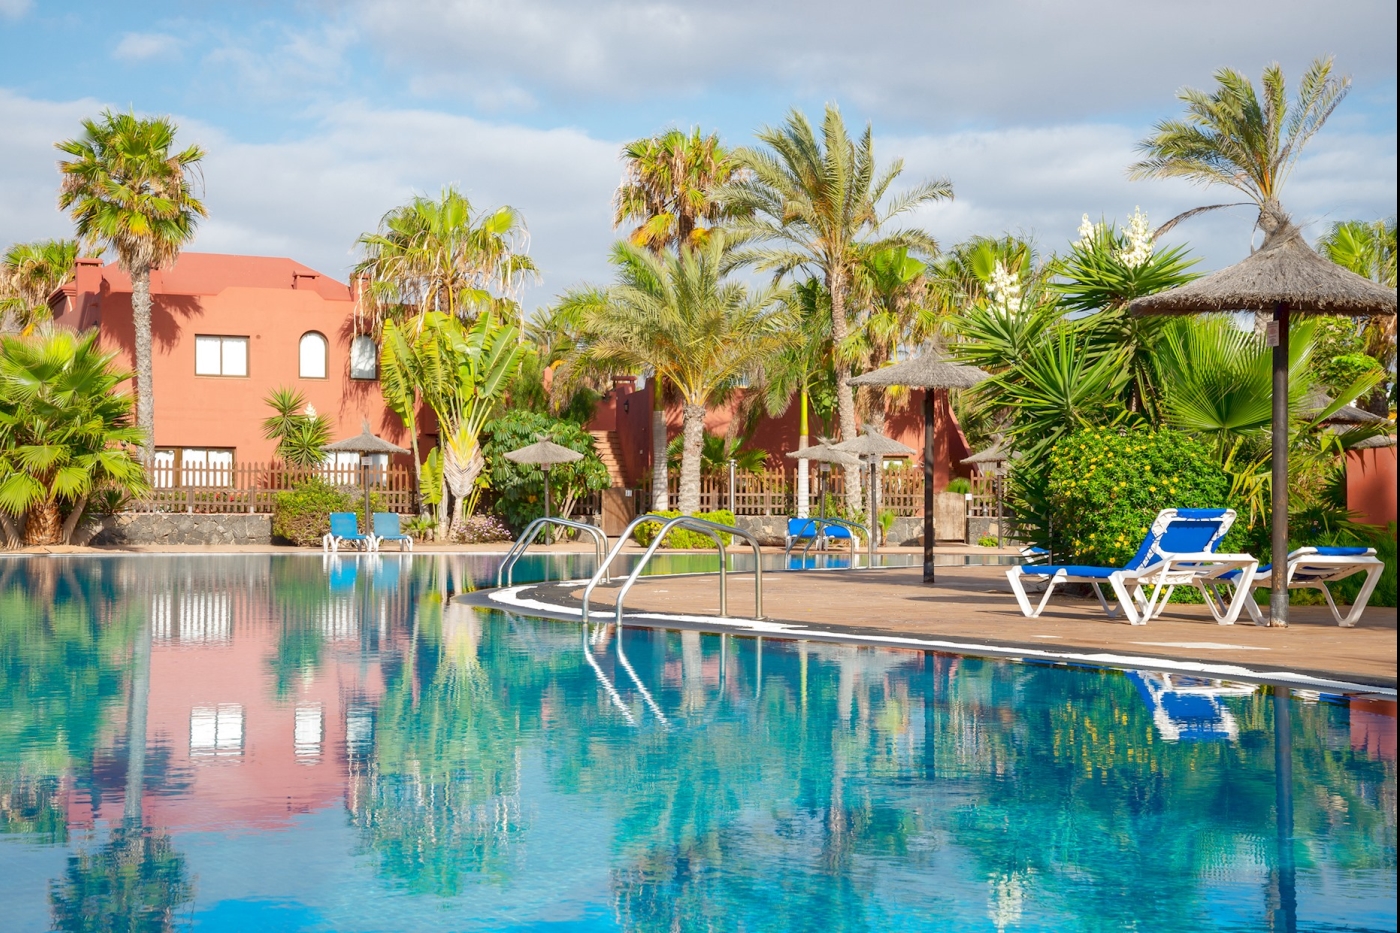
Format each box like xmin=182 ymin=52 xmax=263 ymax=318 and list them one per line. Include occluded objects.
xmin=57 ymin=111 xmax=209 ymax=464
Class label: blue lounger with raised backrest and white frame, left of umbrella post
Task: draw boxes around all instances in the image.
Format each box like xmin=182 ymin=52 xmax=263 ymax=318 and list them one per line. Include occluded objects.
xmin=1007 ymin=509 xmax=1259 ymax=625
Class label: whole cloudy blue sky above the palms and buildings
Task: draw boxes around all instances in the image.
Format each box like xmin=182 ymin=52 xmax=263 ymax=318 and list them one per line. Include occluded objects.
xmin=0 ymin=0 xmax=1396 ymax=312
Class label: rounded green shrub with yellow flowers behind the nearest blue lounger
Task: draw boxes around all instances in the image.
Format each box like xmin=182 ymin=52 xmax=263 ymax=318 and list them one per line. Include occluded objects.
xmin=1046 ymin=429 xmax=1233 ymax=566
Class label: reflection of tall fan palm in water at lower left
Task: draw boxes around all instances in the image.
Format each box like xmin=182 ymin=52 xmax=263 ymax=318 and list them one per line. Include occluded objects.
xmin=49 ymin=602 xmax=195 ymax=933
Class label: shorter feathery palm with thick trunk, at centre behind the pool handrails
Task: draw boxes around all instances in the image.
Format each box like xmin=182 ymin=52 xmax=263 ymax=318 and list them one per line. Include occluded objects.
xmin=571 ymin=231 xmax=787 ymax=513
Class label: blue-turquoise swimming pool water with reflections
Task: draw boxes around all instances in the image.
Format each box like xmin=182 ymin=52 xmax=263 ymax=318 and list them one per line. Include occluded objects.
xmin=0 ymin=553 xmax=1396 ymax=933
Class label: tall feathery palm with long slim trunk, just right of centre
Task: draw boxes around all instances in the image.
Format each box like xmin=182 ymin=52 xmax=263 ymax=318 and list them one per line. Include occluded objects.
xmin=718 ymin=105 xmax=953 ymax=510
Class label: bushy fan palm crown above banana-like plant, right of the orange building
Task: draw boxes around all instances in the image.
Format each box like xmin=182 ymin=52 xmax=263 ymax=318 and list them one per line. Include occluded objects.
xmin=354 ymin=188 xmax=538 ymax=329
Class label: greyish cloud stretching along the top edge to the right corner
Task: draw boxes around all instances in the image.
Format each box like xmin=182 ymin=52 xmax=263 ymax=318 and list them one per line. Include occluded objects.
xmin=358 ymin=0 xmax=1396 ymax=126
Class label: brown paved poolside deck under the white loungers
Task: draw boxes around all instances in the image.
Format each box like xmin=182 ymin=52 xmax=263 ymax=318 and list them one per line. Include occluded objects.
xmin=506 ymin=567 xmax=1396 ymax=688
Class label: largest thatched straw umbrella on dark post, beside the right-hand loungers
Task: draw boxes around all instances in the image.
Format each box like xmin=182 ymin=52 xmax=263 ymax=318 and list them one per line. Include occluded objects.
xmin=1128 ymin=212 xmax=1396 ymax=625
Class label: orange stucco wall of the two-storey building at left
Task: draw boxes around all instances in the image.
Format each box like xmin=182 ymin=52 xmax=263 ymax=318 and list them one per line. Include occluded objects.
xmin=55 ymin=254 xmax=409 ymax=462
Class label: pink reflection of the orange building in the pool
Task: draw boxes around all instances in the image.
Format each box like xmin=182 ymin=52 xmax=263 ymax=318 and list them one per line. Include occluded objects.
xmin=70 ymin=555 xmax=425 ymax=829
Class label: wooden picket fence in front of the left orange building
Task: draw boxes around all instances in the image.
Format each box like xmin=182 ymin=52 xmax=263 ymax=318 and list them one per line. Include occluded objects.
xmin=126 ymin=462 xmax=414 ymax=514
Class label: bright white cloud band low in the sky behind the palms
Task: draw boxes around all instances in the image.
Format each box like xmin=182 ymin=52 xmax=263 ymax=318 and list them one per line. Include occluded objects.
xmin=0 ymin=90 xmax=1397 ymax=318
